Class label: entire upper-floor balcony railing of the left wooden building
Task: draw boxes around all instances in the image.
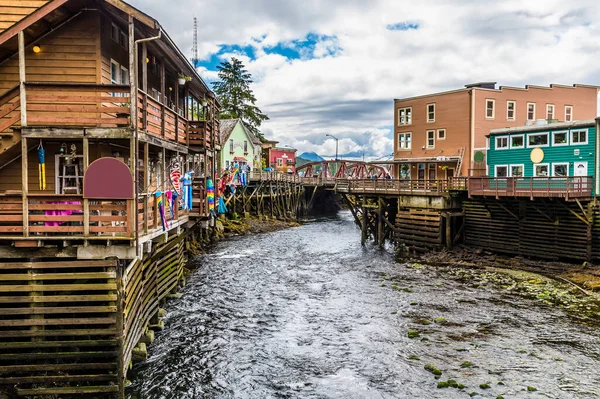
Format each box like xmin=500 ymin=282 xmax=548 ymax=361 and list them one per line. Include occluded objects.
xmin=0 ymin=82 xmax=218 ymax=149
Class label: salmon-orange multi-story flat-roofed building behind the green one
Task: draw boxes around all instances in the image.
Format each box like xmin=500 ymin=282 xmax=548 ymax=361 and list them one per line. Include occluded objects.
xmin=394 ymin=82 xmax=599 ymax=180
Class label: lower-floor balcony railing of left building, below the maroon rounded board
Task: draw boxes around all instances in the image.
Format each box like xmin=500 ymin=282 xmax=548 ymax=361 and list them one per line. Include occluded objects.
xmin=0 ymin=194 xmax=188 ymax=241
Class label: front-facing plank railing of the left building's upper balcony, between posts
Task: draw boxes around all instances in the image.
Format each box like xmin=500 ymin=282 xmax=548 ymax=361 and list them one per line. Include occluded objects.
xmin=25 ymin=83 xmax=131 ymax=127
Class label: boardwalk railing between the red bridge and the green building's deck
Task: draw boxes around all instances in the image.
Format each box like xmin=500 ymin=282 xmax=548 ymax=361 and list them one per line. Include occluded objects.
xmin=336 ymin=177 xmax=467 ymax=194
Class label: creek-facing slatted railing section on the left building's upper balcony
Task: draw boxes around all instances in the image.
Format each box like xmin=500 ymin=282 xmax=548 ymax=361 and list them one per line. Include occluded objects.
xmin=138 ymin=90 xmax=188 ymax=145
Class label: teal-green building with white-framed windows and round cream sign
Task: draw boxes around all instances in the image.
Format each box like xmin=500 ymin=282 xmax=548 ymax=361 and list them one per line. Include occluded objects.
xmin=487 ymin=120 xmax=599 ymax=197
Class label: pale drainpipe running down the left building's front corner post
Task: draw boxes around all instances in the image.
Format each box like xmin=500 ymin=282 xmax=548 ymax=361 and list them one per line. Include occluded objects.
xmin=129 ymin=15 xmax=162 ymax=259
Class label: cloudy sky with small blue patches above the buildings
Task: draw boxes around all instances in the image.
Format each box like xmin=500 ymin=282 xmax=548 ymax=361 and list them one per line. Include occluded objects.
xmin=130 ymin=0 xmax=600 ymax=159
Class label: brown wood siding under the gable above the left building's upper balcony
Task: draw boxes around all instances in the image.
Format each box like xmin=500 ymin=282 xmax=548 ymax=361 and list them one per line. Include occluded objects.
xmin=0 ymin=11 xmax=100 ymax=95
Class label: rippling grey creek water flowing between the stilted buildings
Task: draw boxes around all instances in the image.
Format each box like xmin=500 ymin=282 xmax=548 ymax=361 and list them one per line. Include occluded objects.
xmin=128 ymin=212 xmax=600 ymax=399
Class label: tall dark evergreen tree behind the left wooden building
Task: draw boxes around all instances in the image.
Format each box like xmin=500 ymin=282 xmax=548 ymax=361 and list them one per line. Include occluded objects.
xmin=213 ymin=57 xmax=269 ymax=140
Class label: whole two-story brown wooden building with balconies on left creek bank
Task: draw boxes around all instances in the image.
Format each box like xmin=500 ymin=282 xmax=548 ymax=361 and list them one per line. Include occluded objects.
xmin=0 ymin=0 xmax=220 ymax=398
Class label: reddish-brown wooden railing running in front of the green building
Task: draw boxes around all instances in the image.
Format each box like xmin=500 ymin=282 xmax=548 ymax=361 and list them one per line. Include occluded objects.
xmin=469 ymin=176 xmax=593 ymax=199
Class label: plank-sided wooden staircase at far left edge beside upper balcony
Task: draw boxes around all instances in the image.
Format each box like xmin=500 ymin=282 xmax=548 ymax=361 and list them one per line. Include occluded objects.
xmin=0 ymin=85 xmax=21 ymax=164
